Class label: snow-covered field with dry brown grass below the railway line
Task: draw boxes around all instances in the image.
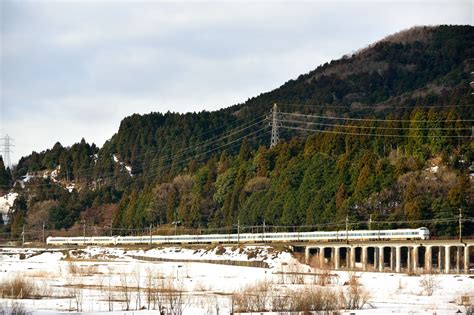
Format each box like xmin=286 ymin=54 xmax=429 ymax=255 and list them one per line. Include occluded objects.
xmin=0 ymin=246 xmax=474 ymax=315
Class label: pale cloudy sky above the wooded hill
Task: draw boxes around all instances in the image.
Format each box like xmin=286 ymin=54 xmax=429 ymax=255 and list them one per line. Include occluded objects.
xmin=0 ymin=0 xmax=474 ymax=164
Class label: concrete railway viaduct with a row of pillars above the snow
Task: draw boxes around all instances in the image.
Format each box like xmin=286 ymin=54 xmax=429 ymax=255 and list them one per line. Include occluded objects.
xmin=293 ymin=240 xmax=474 ymax=273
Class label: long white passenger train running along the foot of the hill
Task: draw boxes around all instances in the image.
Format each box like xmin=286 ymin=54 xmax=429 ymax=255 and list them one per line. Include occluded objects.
xmin=46 ymin=227 xmax=430 ymax=245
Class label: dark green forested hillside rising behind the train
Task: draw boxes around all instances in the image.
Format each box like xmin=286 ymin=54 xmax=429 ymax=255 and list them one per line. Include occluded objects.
xmin=0 ymin=26 xmax=474 ymax=236
